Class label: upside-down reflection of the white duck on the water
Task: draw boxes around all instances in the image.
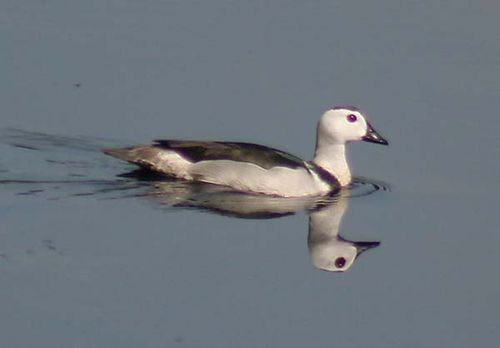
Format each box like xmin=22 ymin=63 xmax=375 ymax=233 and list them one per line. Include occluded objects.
xmin=122 ymin=170 xmax=380 ymax=272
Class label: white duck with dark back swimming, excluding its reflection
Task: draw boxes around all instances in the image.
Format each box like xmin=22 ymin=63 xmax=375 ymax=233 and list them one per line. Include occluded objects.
xmin=102 ymin=106 xmax=389 ymax=197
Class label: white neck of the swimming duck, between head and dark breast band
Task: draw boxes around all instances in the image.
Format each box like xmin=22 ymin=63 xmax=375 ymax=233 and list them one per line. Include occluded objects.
xmin=313 ymin=139 xmax=352 ymax=186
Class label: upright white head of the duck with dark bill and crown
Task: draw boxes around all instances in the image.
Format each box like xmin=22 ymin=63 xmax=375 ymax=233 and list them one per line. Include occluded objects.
xmin=318 ymin=106 xmax=388 ymax=145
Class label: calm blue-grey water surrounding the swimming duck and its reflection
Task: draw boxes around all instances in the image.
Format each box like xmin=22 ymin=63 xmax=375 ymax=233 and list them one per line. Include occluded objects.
xmin=0 ymin=0 xmax=500 ymax=348
